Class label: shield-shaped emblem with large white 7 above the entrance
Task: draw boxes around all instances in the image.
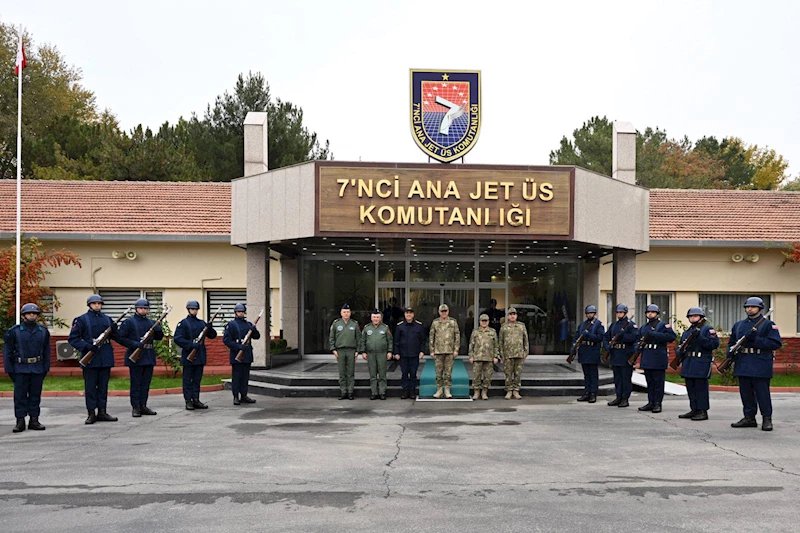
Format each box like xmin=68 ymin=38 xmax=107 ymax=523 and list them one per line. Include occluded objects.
xmin=411 ymin=70 xmax=481 ymax=163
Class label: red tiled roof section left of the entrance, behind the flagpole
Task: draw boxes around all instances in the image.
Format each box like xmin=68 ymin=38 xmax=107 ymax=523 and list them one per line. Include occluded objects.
xmin=0 ymin=180 xmax=231 ymax=237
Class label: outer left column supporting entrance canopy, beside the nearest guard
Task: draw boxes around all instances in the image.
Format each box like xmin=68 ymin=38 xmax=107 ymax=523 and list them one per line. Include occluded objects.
xmin=247 ymin=244 xmax=270 ymax=366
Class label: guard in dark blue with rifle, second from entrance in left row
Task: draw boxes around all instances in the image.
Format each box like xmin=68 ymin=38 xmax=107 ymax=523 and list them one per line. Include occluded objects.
xmin=174 ymin=300 xmax=217 ymax=411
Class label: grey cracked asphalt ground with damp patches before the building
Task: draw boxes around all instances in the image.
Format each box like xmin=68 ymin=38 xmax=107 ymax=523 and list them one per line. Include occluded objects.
xmin=0 ymin=391 xmax=800 ymax=532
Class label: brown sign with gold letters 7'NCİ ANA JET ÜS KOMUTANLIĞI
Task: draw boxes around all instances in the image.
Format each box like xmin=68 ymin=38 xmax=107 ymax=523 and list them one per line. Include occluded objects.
xmin=317 ymin=165 xmax=572 ymax=236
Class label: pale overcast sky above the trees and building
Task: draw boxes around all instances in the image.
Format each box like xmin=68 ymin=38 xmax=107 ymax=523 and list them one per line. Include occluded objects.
xmin=6 ymin=0 xmax=800 ymax=176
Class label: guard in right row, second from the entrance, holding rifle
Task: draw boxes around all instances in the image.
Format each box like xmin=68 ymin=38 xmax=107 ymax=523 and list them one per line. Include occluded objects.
xmin=604 ymin=304 xmax=638 ymax=407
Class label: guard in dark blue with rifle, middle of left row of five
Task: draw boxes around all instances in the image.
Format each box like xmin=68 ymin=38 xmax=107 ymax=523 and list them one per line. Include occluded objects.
xmin=118 ymin=298 xmax=164 ymax=418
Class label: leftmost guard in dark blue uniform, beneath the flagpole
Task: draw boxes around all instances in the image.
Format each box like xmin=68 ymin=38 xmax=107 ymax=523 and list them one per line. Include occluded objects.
xmin=3 ymin=304 xmax=50 ymax=433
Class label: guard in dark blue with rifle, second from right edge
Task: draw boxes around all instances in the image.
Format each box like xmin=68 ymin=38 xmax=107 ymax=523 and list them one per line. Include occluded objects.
xmin=675 ymin=307 xmax=719 ymax=420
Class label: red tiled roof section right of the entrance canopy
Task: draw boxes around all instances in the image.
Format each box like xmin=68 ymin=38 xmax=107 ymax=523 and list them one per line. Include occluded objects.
xmin=650 ymin=189 xmax=800 ymax=242
